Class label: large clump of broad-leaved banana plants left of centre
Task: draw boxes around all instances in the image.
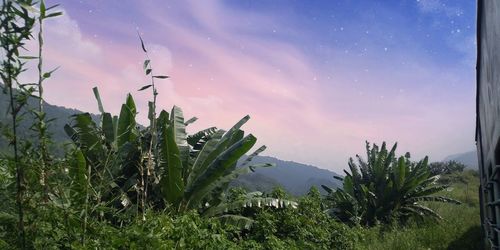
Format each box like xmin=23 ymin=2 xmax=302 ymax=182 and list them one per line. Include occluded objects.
xmin=65 ymin=88 xmax=273 ymax=218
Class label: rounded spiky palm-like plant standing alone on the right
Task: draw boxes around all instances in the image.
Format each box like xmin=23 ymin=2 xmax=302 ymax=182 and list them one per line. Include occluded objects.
xmin=323 ymin=142 xmax=460 ymax=225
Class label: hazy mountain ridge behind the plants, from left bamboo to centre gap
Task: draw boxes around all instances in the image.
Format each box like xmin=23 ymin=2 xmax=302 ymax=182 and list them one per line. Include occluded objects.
xmin=0 ymin=89 xmax=340 ymax=195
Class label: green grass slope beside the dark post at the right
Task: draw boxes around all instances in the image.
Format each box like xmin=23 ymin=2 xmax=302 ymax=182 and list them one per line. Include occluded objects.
xmin=356 ymin=171 xmax=483 ymax=250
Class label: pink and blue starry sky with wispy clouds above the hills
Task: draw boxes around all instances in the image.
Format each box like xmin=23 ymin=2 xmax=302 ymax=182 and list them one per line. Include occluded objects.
xmin=33 ymin=0 xmax=476 ymax=172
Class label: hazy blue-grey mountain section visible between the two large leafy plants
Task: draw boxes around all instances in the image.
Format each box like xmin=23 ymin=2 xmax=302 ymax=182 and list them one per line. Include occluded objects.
xmin=232 ymin=156 xmax=341 ymax=196
